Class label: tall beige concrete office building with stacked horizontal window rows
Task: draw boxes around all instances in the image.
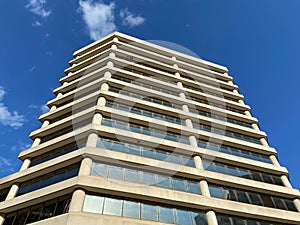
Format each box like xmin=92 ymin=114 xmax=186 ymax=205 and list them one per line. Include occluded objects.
xmin=0 ymin=32 xmax=300 ymax=225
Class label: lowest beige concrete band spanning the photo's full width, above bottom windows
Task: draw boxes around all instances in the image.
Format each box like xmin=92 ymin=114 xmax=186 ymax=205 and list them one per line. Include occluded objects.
xmin=0 ymin=176 xmax=300 ymax=224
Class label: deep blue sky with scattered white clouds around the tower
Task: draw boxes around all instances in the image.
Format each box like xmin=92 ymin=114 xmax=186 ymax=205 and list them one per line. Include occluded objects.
xmin=0 ymin=0 xmax=300 ymax=189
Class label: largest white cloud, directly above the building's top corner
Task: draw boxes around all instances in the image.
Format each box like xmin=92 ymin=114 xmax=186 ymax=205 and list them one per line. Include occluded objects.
xmin=78 ymin=0 xmax=117 ymax=40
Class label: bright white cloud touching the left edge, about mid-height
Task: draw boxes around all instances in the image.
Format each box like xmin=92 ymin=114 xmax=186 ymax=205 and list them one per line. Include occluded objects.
xmin=0 ymin=86 xmax=24 ymax=128
